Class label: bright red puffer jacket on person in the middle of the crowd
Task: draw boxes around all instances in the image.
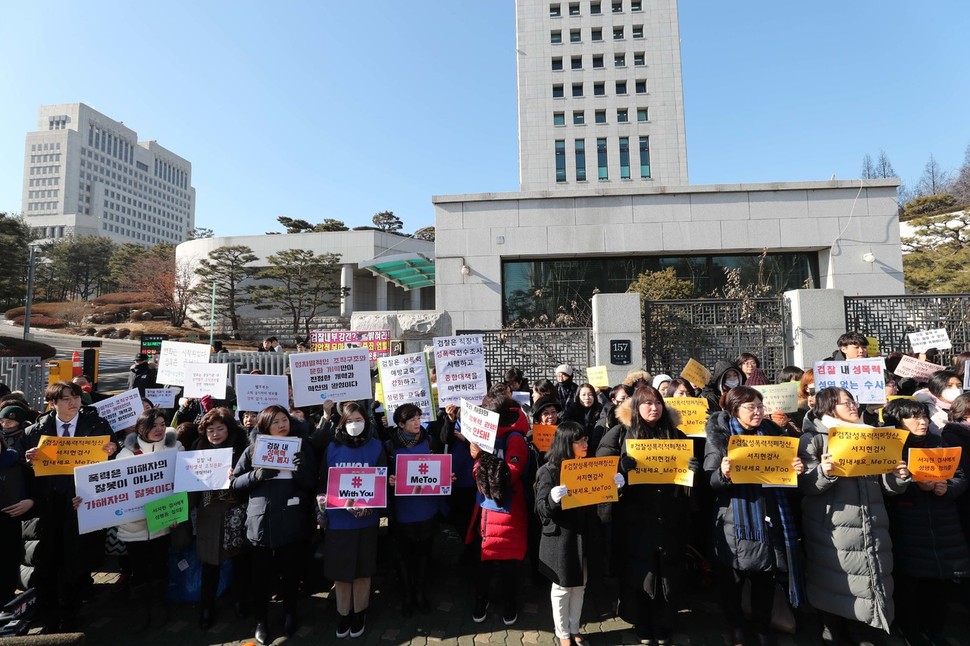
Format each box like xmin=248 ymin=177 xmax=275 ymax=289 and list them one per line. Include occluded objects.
xmin=467 ymin=409 xmax=529 ymax=561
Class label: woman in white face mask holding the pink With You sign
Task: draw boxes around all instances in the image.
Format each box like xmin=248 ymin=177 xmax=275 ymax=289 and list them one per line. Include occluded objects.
xmin=317 ymin=402 xmax=387 ymax=638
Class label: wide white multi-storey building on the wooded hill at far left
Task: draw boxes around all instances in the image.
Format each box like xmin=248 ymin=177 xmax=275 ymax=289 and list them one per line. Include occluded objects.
xmin=23 ymin=103 xmax=195 ymax=245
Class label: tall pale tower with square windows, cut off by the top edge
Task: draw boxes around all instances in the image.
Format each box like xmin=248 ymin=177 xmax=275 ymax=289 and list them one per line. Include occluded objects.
xmin=516 ymin=0 xmax=687 ymax=191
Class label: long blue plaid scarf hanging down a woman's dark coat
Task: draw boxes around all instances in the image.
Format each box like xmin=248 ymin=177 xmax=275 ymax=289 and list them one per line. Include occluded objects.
xmin=731 ymin=417 xmax=802 ymax=608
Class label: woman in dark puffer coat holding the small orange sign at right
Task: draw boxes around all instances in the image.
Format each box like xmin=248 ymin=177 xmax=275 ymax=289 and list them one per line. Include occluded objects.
xmin=882 ymin=399 xmax=970 ymax=644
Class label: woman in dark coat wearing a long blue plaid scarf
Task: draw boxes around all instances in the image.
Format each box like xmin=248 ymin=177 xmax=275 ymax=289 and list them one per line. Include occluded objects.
xmin=704 ymin=386 xmax=805 ymax=644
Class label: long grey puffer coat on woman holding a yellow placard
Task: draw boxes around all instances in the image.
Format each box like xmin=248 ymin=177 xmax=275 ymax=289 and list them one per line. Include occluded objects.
xmin=798 ymin=413 xmax=909 ymax=632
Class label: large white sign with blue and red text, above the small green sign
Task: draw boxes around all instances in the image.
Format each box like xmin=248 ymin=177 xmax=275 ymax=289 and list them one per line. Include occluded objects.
xmin=74 ymin=450 xmax=178 ymax=534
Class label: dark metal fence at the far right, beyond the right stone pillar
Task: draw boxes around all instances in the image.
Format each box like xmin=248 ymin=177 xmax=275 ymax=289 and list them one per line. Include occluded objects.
xmin=845 ymin=294 xmax=970 ymax=365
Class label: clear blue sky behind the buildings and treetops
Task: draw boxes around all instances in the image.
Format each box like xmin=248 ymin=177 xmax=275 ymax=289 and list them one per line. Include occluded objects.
xmin=0 ymin=0 xmax=970 ymax=235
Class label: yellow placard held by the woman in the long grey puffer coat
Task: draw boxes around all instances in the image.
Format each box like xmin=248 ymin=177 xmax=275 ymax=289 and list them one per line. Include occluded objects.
xmin=829 ymin=427 xmax=909 ymax=477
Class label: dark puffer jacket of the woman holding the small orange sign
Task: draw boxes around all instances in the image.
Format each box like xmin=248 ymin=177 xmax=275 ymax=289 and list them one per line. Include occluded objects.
xmin=886 ymin=433 xmax=970 ymax=579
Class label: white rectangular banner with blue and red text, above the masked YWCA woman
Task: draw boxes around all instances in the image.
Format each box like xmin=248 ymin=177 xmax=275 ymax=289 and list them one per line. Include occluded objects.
xmin=290 ymin=348 xmax=371 ymax=407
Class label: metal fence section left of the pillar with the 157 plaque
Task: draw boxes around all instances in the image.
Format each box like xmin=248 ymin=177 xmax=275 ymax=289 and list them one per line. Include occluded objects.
xmin=456 ymin=327 xmax=594 ymax=384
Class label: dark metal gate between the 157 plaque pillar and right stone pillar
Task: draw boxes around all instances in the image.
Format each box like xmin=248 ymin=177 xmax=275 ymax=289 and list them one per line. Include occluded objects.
xmin=643 ymin=296 xmax=790 ymax=383
